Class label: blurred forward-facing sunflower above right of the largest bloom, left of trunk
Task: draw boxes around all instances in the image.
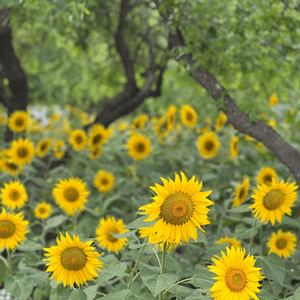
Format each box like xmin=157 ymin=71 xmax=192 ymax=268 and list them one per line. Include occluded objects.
xmin=198 ymin=132 xmax=221 ymax=159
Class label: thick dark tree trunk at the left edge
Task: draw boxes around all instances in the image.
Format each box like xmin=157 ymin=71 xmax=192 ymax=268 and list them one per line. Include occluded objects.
xmin=0 ymin=9 xmax=28 ymax=141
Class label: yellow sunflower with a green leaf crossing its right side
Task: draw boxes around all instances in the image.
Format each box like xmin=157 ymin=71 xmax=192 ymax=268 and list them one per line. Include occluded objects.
xmin=96 ymin=217 xmax=128 ymax=254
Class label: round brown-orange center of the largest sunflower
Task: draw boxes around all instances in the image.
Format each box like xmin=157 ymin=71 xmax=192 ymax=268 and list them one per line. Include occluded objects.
xmin=160 ymin=192 xmax=194 ymax=225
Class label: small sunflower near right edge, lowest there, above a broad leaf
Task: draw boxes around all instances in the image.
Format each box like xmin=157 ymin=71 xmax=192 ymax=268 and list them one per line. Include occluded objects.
xmin=267 ymin=229 xmax=297 ymax=258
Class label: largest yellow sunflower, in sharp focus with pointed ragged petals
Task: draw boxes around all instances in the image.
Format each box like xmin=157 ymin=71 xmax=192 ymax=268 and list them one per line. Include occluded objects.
xmin=140 ymin=172 xmax=213 ymax=244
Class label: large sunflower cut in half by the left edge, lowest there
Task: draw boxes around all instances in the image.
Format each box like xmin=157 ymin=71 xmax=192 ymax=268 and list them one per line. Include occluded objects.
xmin=0 ymin=208 xmax=29 ymax=249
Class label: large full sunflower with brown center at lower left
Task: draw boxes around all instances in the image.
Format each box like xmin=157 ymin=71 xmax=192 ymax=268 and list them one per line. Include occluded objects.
xmin=44 ymin=233 xmax=103 ymax=288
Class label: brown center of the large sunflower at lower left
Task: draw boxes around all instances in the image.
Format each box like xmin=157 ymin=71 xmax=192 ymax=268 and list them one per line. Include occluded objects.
xmin=60 ymin=247 xmax=87 ymax=271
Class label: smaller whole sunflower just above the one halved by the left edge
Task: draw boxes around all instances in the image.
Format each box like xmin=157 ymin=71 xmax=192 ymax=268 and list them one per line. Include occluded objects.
xmin=0 ymin=181 xmax=28 ymax=209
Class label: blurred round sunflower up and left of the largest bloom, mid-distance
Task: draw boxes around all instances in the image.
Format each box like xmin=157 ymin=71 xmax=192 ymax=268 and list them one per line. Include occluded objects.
xmin=127 ymin=134 xmax=151 ymax=160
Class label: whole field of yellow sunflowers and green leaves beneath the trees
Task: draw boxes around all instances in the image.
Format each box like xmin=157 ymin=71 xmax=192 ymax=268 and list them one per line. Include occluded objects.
xmin=0 ymin=101 xmax=300 ymax=300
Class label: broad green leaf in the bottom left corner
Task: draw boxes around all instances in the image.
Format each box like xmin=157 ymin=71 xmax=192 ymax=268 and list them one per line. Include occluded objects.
xmin=4 ymin=274 xmax=33 ymax=300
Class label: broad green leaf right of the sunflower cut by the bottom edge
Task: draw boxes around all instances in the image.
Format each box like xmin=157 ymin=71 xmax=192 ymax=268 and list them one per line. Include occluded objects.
xmin=255 ymin=253 xmax=285 ymax=284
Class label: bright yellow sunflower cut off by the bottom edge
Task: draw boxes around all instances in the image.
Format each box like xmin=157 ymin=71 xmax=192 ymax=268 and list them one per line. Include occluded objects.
xmin=208 ymin=247 xmax=264 ymax=300
